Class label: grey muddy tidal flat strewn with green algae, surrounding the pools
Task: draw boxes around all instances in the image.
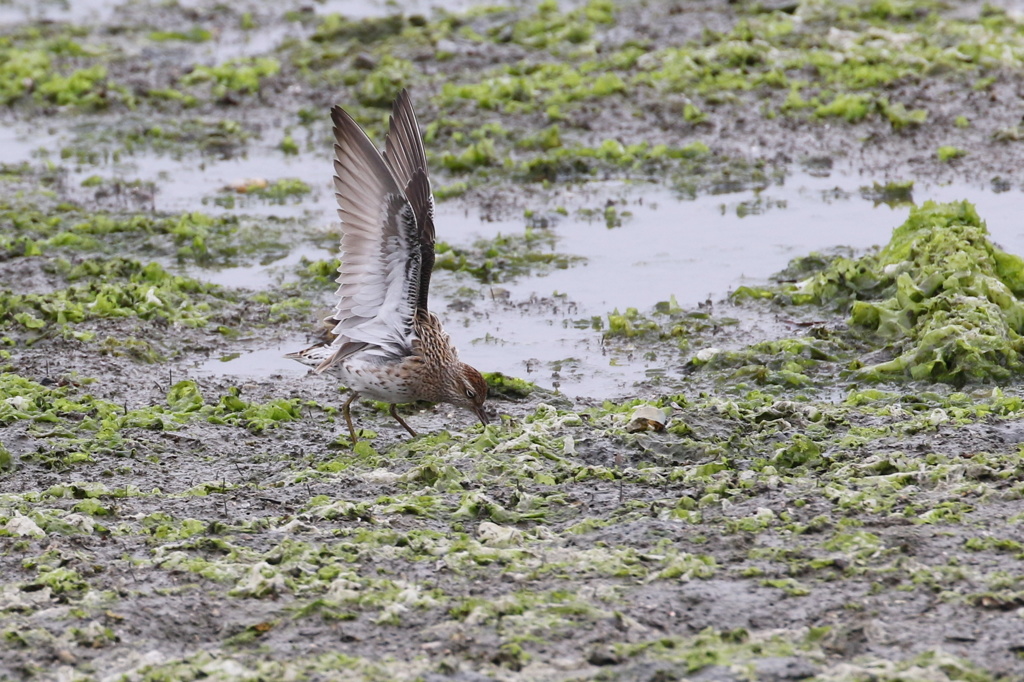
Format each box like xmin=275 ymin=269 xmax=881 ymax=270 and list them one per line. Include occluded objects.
xmin=0 ymin=0 xmax=1024 ymax=682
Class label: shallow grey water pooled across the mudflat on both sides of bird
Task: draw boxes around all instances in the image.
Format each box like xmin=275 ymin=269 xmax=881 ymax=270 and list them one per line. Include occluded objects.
xmin=8 ymin=111 xmax=1024 ymax=396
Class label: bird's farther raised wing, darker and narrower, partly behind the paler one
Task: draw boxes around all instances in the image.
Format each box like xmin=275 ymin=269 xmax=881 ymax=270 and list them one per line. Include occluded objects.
xmin=384 ymin=89 xmax=434 ymax=310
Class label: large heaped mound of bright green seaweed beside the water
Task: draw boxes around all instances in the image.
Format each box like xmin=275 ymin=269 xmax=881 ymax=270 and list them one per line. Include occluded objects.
xmin=785 ymin=201 xmax=1024 ymax=385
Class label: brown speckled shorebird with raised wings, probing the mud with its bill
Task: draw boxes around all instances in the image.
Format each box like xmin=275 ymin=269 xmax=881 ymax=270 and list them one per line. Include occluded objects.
xmin=286 ymin=90 xmax=488 ymax=444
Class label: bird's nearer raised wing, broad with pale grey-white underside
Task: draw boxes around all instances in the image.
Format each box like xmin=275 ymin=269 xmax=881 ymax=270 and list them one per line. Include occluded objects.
xmin=316 ymin=106 xmax=421 ymax=372
